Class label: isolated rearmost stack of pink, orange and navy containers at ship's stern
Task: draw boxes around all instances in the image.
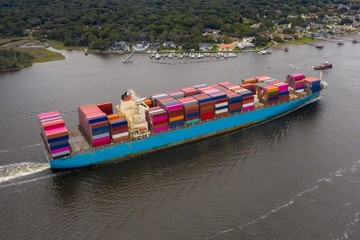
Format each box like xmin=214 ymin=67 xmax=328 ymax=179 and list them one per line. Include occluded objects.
xmin=38 ymin=111 xmax=70 ymax=158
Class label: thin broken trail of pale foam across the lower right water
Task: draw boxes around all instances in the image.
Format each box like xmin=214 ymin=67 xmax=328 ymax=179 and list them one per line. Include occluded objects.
xmin=205 ymin=161 xmax=360 ymax=240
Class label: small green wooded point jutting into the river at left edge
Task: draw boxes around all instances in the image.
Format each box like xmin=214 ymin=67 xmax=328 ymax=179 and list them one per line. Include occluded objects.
xmin=0 ymin=49 xmax=34 ymax=71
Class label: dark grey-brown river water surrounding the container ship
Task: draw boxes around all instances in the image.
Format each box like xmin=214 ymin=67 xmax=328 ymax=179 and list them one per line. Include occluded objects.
xmin=0 ymin=38 xmax=360 ymax=240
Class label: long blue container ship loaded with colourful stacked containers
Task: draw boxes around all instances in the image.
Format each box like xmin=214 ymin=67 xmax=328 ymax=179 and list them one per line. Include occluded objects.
xmin=38 ymin=73 xmax=327 ymax=169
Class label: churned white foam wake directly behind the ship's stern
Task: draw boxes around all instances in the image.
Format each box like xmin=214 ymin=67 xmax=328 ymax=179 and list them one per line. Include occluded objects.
xmin=0 ymin=162 xmax=50 ymax=183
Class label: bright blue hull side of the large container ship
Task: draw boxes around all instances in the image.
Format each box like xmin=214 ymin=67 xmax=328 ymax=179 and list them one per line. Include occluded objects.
xmin=46 ymin=92 xmax=320 ymax=169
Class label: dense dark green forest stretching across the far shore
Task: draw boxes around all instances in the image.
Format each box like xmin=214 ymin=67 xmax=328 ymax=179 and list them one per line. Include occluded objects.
xmin=0 ymin=0 xmax=360 ymax=50
